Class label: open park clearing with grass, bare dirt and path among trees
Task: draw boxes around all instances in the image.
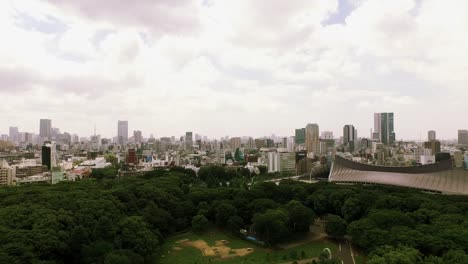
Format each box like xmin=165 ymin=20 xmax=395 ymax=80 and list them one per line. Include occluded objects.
xmin=158 ymin=221 xmax=364 ymax=264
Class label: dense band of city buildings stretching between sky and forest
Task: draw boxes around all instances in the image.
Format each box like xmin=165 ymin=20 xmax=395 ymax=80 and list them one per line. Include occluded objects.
xmin=0 ymin=113 xmax=468 ymax=185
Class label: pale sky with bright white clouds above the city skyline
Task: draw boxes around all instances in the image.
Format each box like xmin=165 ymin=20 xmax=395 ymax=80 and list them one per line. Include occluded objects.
xmin=0 ymin=0 xmax=468 ymax=139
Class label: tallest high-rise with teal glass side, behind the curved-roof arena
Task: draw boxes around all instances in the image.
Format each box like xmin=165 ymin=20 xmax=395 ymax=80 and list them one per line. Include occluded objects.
xmin=372 ymin=113 xmax=395 ymax=145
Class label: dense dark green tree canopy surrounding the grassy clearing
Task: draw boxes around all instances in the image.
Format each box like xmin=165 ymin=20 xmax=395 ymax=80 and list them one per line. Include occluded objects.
xmin=0 ymin=166 xmax=468 ymax=264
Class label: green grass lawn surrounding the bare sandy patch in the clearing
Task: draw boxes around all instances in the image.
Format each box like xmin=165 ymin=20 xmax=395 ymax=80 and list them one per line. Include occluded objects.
xmin=158 ymin=230 xmax=337 ymax=264
